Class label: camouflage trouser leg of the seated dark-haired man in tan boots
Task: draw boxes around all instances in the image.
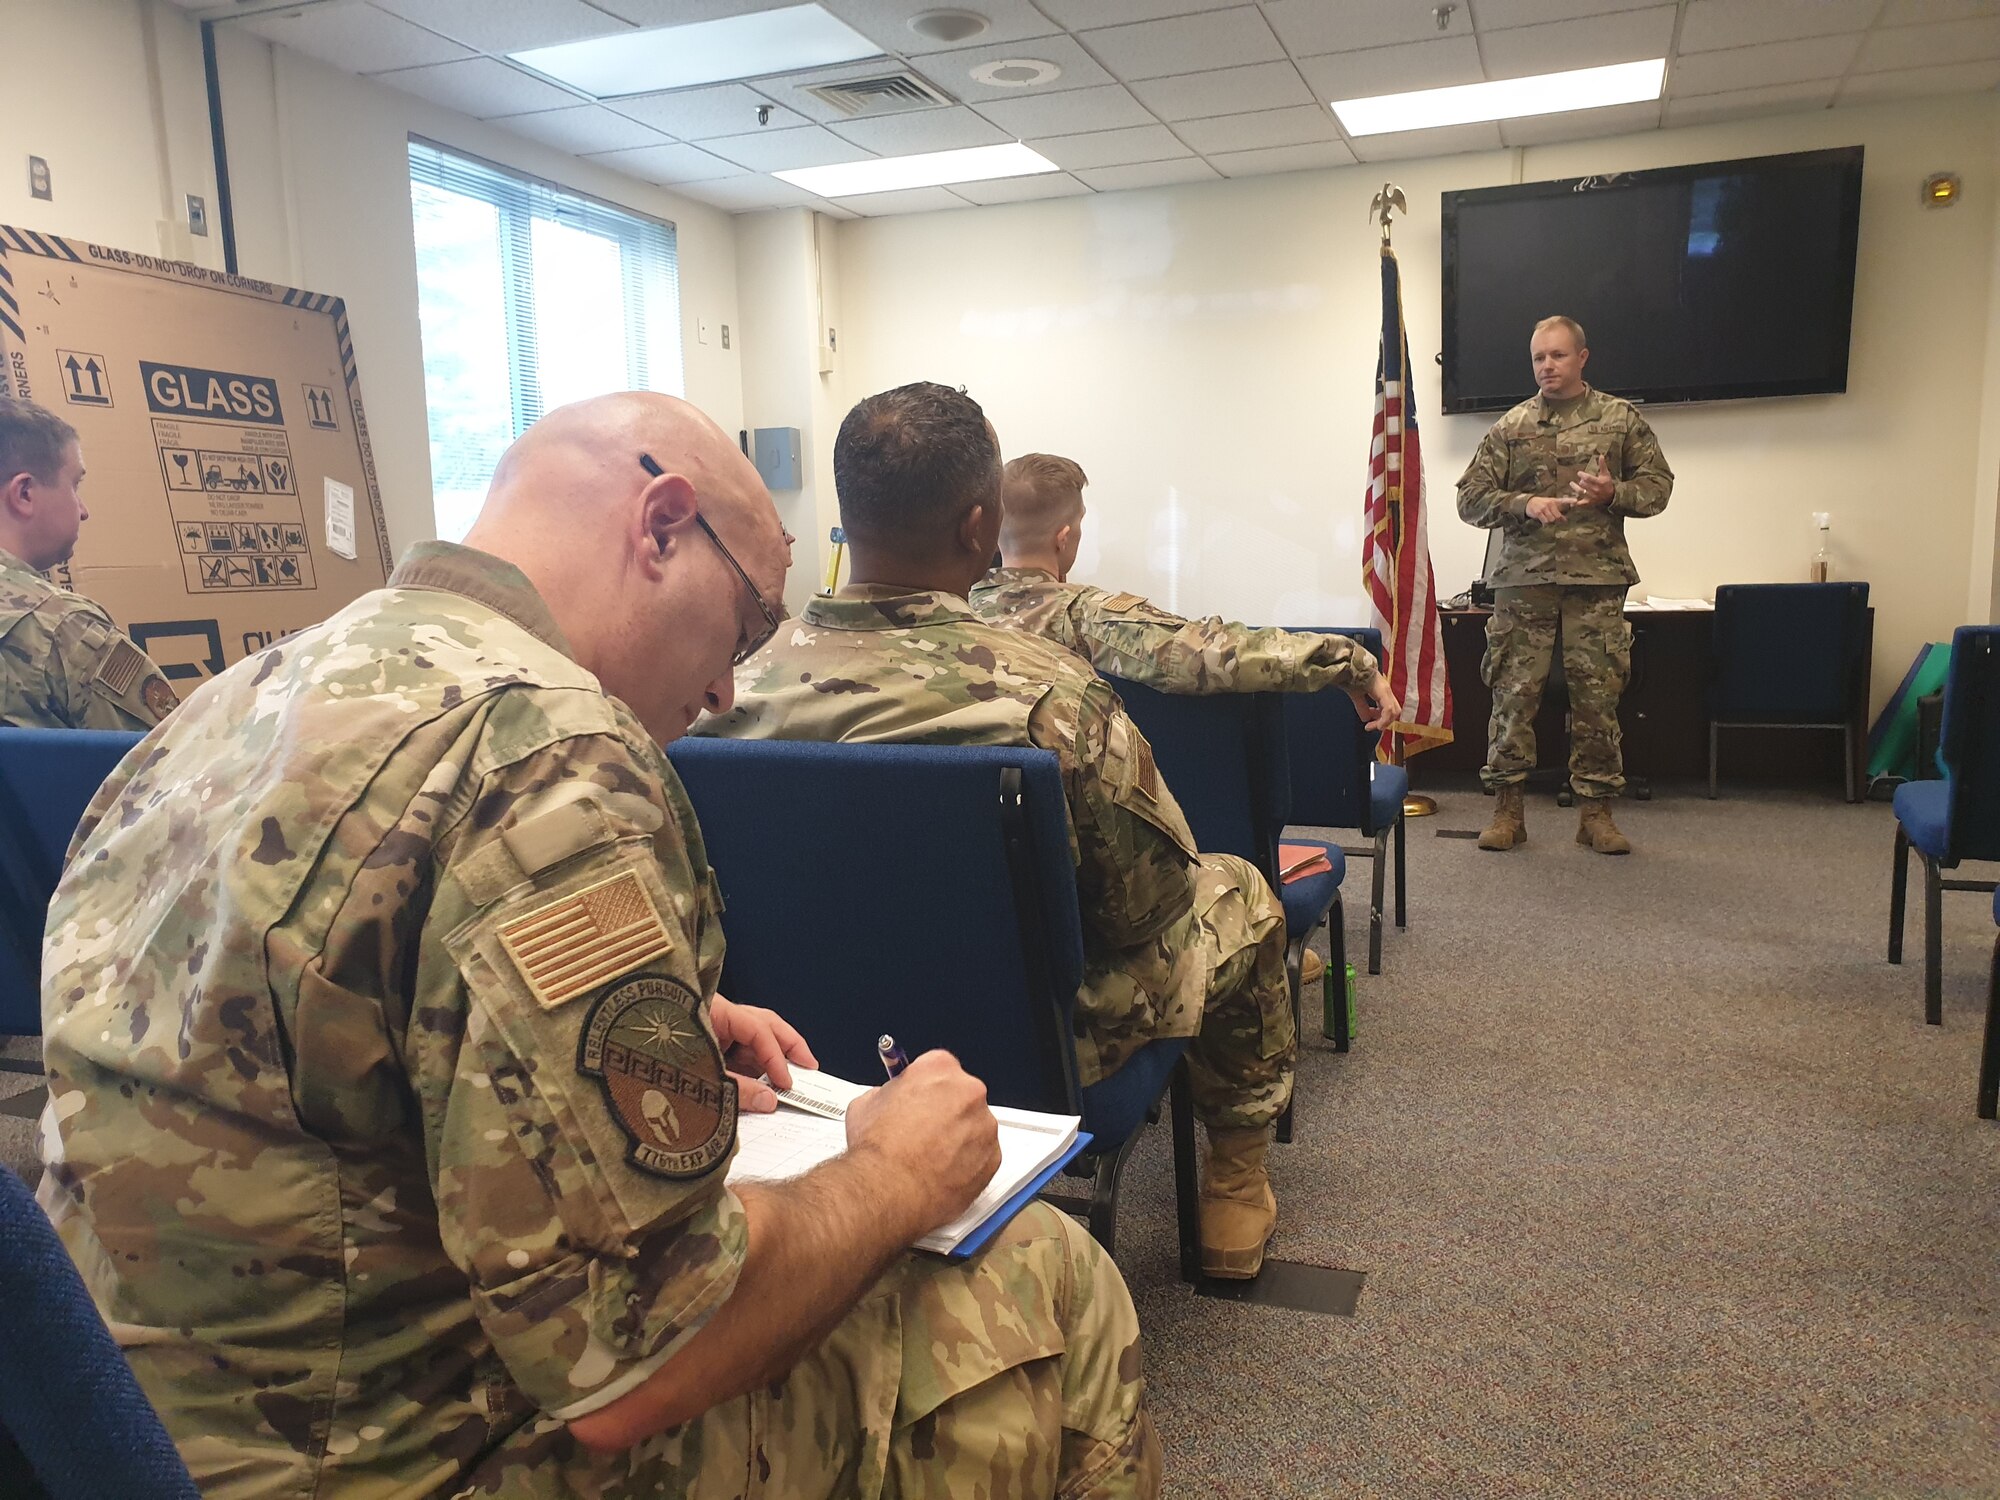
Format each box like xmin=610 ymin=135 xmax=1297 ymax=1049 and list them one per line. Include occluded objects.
xmin=1188 ymin=854 xmax=1298 ymax=1130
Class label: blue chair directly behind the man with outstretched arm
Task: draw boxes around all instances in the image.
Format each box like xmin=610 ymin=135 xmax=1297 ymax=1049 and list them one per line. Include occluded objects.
xmin=1108 ymin=678 xmax=1348 ymax=1140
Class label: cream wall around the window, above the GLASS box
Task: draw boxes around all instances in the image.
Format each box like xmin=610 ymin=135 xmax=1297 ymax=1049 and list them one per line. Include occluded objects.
xmin=0 ymin=0 xmax=742 ymax=552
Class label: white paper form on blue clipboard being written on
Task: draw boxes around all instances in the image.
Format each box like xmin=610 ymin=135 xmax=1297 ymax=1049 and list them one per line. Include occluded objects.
xmin=728 ymin=1068 xmax=1090 ymax=1260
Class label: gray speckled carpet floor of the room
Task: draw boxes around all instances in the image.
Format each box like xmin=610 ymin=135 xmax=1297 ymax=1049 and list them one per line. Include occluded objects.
xmin=0 ymin=788 xmax=2000 ymax=1500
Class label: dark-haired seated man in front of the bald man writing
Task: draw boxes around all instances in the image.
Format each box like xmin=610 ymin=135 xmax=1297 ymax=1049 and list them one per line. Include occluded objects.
xmin=696 ymin=384 xmax=1296 ymax=1276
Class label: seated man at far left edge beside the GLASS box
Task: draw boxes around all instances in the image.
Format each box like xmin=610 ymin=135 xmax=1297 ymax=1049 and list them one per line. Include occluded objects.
xmin=0 ymin=396 xmax=178 ymax=730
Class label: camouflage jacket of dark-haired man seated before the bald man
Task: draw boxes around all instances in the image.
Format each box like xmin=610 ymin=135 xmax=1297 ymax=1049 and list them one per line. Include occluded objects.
xmin=694 ymin=584 xmax=1210 ymax=1084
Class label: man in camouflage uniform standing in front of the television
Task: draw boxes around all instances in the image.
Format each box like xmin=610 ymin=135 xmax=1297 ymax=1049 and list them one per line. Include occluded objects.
xmin=1458 ymin=318 xmax=1674 ymax=854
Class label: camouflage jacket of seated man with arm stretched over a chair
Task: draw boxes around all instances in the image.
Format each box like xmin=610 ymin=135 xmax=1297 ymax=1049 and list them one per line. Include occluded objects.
xmin=972 ymin=568 xmax=1376 ymax=692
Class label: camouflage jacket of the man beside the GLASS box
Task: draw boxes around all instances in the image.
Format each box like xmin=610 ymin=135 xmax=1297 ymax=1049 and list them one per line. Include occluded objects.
xmin=0 ymin=550 xmax=178 ymax=730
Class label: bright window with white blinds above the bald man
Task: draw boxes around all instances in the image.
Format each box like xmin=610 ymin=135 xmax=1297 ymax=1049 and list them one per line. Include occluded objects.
xmin=410 ymin=140 xmax=682 ymax=542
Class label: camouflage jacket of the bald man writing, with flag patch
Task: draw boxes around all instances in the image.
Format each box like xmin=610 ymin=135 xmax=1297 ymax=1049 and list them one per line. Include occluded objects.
xmin=42 ymin=542 xmax=746 ymax=1500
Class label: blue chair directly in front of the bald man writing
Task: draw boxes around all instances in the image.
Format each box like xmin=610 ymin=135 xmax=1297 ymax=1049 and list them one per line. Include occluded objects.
xmin=668 ymin=740 xmax=1200 ymax=1280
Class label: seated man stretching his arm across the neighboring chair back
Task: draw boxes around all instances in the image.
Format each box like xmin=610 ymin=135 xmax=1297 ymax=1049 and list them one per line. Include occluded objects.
xmin=972 ymin=454 xmax=1400 ymax=730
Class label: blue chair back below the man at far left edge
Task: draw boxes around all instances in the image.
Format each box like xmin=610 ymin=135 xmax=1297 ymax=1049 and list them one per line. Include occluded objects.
xmin=0 ymin=728 xmax=140 ymax=1036
